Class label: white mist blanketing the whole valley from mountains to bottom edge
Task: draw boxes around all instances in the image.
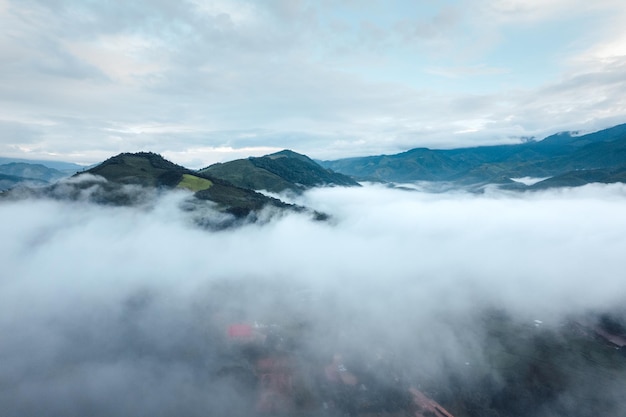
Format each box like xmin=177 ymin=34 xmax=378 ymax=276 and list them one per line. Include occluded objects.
xmin=0 ymin=177 xmax=626 ymax=417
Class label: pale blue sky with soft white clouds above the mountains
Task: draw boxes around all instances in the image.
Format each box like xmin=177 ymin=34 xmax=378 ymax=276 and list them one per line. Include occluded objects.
xmin=0 ymin=0 xmax=626 ymax=168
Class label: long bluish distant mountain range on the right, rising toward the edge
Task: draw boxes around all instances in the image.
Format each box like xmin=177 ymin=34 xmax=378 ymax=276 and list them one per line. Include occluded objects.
xmin=321 ymin=124 xmax=626 ymax=184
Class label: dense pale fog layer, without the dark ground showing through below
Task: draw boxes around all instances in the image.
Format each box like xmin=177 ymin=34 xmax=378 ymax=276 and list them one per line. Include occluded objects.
xmin=0 ymin=184 xmax=626 ymax=417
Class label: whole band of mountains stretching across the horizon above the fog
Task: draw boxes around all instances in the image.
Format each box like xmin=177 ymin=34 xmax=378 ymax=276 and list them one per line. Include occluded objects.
xmin=0 ymin=124 xmax=626 ymax=202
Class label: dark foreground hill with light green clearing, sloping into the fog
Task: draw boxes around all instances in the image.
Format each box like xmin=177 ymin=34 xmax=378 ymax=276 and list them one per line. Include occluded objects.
xmin=1 ymin=152 xmax=326 ymax=227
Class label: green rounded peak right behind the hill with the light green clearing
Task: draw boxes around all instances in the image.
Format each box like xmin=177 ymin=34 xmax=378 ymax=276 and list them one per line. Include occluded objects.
xmin=198 ymin=150 xmax=359 ymax=193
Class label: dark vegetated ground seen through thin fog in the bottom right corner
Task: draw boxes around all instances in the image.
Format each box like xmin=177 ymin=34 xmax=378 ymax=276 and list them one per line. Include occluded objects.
xmin=423 ymin=311 xmax=626 ymax=417
